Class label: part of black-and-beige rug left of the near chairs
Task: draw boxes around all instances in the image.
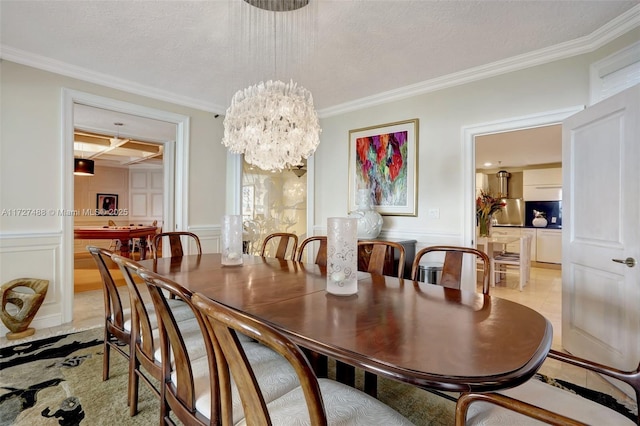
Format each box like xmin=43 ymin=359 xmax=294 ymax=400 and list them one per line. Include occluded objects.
xmin=0 ymin=328 xmax=160 ymax=426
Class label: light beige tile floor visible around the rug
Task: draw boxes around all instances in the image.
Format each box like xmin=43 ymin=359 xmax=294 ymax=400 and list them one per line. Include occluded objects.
xmin=0 ymin=268 xmax=627 ymax=408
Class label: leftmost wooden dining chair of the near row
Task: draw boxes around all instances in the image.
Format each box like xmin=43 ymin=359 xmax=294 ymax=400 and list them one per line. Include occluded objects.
xmin=87 ymin=246 xmax=131 ymax=381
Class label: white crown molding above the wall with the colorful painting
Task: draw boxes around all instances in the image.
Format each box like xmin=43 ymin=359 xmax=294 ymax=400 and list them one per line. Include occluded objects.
xmin=318 ymin=5 xmax=640 ymax=118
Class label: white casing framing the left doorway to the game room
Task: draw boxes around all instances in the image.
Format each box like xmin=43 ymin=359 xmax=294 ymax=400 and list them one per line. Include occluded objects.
xmin=60 ymin=88 xmax=189 ymax=323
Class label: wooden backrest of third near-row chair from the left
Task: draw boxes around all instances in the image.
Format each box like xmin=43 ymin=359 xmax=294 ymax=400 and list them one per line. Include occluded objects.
xmin=138 ymin=269 xmax=219 ymax=425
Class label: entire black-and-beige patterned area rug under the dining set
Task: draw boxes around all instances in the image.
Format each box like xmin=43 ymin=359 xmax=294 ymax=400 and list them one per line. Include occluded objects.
xmin=0 ymin=328 xmax=637 ymax=426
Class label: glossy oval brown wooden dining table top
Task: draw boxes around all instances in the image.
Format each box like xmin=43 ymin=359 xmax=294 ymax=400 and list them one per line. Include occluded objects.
xmin=140 ymin=254 xmax=552 ymax=392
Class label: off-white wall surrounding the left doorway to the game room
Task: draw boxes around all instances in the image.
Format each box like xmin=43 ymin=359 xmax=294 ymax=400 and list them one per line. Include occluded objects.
xmin=0 ymin=60 xmax=226 ymax=332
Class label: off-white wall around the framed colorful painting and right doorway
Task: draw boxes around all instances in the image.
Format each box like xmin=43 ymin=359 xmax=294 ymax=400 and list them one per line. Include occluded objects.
xmin=314 ymin=30 xmax=640 ymax=248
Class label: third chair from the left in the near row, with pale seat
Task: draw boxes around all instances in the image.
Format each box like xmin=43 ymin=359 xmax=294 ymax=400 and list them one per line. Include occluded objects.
xmin=138 ymin=269 xmax=299 ymax=425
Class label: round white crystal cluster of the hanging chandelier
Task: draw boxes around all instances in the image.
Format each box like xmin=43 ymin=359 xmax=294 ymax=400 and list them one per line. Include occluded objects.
xmin=222 ymin=80 xmax=322 ymax=170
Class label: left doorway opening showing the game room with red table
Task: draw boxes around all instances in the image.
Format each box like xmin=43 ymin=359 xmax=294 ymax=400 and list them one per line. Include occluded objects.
xmin=74 ymin=104 xmax=176 ymax=293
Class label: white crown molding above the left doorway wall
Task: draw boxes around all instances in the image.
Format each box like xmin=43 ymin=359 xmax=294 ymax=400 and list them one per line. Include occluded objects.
xmin=0 ymin=45 xmax=226 ymax=114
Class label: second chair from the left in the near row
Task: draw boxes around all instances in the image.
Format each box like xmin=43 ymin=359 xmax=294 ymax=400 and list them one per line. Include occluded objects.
xmin=112 ymin=254 xmax=204 ymax=416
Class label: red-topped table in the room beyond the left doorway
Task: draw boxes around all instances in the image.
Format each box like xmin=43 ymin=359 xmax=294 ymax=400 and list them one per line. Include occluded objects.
xmin=73 ymin=225 xmax=158 ymax=260
